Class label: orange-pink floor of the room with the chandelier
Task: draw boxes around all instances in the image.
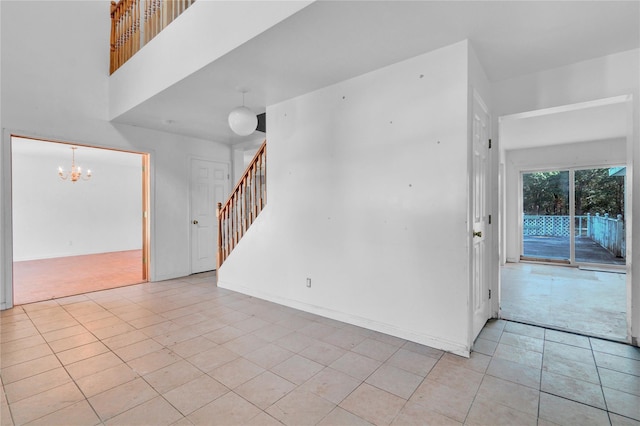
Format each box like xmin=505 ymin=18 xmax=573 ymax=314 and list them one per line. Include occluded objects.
xmin=13 ymin=250 xmax=144 ymax=305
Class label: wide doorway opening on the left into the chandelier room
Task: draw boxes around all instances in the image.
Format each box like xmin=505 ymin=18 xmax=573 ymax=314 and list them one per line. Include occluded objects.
xmin=11 ymin=136 xmax=149 ymax=305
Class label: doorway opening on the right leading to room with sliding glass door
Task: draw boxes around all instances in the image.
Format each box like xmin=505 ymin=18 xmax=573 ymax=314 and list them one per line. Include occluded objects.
xmin=499 ymin=96 xmax=632 ymax=342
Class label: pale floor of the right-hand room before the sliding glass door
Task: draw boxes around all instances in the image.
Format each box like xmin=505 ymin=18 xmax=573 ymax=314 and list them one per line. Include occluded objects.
xmin=500 ymin=262 xmax=627 ymax=341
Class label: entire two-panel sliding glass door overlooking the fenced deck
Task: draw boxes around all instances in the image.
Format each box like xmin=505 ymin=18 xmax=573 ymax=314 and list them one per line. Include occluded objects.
xmin=521 ymin=167 xmax=626 ymax=265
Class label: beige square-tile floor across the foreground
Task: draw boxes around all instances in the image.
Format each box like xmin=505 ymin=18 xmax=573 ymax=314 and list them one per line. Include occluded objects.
xmin=0 ymin=274 xmax=640 ymax=425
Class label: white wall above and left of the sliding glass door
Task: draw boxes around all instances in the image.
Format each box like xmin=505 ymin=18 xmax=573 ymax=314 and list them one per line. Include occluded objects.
xmin=505 ymin=138 xmax=627 ymax=262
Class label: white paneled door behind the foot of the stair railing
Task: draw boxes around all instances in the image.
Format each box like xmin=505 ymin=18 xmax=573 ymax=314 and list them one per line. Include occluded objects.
xmin=191 ymin=159 xmax=229 ymax=274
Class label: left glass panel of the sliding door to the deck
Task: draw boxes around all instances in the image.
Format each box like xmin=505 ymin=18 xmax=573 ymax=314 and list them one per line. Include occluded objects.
xmin=521 ymin=170 xmax=571 ymax=262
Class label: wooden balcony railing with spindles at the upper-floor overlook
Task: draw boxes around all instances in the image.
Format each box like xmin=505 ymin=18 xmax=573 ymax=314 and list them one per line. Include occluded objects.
xmin=110 ymin=0 xmax=196 ymax=74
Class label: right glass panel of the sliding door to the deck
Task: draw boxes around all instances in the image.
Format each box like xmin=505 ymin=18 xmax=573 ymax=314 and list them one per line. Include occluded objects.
xmin=574 ymin=167 xmax=626 ymax=265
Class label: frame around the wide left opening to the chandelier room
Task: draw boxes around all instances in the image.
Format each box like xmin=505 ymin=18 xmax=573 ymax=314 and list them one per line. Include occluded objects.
xmin=0 ymin=134 xmax=152 ymax=310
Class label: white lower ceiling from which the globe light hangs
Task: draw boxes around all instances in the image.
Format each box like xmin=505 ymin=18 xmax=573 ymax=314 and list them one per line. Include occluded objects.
xmin=114 ymin=0 xmax=640 ymax=143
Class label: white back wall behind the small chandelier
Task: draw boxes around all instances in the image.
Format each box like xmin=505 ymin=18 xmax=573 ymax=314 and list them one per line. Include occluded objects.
xmin=12 ymin=138 xmax=142 ymax=261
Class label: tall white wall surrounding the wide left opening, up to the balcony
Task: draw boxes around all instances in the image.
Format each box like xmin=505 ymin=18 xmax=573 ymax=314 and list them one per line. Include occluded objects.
xmin=0 ymin=1 xmax=230 ymax=309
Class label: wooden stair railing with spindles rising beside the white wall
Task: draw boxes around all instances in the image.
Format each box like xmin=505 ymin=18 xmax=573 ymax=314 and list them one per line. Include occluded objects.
xmin=218 ymin=140 xmax=267 ymax=269
